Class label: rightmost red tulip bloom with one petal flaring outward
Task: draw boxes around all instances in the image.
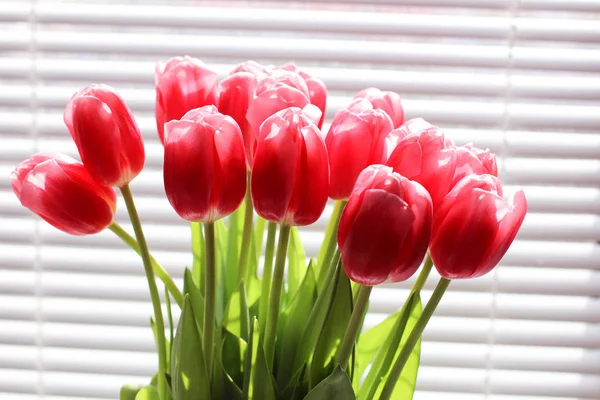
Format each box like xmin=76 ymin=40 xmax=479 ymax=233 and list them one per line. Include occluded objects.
xmin=429 ymin=175 xmax=527 ymax=279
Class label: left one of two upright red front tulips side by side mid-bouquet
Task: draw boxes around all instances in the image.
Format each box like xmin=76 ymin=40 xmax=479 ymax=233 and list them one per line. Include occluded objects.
xmin=164 ymin=106 xmax=246 ymax=222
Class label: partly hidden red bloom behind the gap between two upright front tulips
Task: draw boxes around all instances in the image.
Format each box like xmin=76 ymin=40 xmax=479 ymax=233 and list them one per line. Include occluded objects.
xmin=219 ymin=61 xmax=266 ymax=165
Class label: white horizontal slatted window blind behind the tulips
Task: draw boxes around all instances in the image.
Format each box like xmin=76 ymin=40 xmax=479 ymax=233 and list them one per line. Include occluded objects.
xmin=0 ymin=0 xmax=600 ymax=400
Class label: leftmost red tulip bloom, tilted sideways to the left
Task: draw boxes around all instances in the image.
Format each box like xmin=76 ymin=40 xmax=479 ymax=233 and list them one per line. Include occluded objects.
xmin=10 ymin=153 xmax=117 ymax=235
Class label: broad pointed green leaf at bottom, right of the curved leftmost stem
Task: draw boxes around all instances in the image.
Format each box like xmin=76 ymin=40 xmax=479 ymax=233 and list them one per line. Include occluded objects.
xmin=171 ymin=295 xmax=211 ymax=400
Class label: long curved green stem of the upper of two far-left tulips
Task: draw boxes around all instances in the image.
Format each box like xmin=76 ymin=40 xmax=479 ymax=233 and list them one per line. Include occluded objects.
xmin=121 ymin=185 xmax=167 ymax=400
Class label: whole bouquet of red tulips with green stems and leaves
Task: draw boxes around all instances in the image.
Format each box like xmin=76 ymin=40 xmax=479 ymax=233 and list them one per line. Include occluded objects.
xmin=11 ymin=57 xmax=527 ymax=400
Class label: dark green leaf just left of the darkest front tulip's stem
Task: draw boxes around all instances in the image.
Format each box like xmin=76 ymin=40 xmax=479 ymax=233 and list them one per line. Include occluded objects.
xmin=309 ymin=269 xmax=352 ymax=387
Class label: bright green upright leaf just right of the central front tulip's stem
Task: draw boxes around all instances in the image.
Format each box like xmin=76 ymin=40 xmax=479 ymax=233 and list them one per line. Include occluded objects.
xmin=277 ymin=262 xmax=317 ymax=387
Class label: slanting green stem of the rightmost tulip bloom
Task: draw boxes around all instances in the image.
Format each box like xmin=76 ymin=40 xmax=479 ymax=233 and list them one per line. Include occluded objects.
xmin=379 ymin=278 xmax=450 ymax=400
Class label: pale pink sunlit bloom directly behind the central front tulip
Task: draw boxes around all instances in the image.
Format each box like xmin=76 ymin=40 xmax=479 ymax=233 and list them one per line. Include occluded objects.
xmin=245 ymin=70 xmax=312 ymax=167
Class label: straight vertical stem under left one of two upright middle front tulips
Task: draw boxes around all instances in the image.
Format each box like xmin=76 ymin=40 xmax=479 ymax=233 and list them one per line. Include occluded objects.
xmin=203 ymin=222 xmax=217 ymax=376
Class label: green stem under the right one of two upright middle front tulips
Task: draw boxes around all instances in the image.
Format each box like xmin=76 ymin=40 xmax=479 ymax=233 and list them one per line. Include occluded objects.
xmin=264 ymin=225 xmax=291 ymax=371
